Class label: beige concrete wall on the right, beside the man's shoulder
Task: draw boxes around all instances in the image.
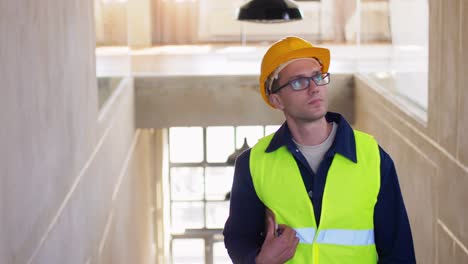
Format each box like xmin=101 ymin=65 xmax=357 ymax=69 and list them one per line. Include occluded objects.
xmin=355 ymin=0 xmax=468 ymax=264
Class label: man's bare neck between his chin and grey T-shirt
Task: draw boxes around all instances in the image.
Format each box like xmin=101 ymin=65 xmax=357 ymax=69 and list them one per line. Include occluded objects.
xmin=286 ymin=117 xmax=333 ymax=146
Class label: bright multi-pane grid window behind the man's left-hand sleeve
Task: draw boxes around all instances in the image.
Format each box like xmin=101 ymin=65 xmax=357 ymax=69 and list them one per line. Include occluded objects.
xmin=169 ymin=126 xmax=279 ymax=264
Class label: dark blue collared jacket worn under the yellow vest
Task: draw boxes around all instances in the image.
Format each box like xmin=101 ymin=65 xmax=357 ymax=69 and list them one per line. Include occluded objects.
xmin=224 ymin=112 xmax=416 ymax=264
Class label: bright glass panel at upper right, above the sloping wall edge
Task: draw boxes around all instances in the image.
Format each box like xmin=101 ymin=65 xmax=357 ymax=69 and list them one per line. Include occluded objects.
xmin=359 ymin=0 xmax=429 ymax=124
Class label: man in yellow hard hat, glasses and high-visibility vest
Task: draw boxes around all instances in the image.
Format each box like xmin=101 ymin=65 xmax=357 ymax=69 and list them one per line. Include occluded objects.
xmin=224 ymin=37 xmax=415 ymax=264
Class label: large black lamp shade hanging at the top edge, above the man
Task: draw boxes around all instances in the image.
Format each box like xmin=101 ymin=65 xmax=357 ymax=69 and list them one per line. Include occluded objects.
xmin=237 ymin=0 xmax=302 ymax=23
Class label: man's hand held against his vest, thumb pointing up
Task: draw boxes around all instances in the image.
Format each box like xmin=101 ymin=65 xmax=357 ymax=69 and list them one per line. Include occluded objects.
xmin=255 ymin=215 xmax=299 ymax=264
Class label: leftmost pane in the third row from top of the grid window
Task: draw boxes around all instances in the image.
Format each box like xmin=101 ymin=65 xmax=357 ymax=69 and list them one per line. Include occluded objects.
xmin=171 ymin=202 xmax=204 ymax=232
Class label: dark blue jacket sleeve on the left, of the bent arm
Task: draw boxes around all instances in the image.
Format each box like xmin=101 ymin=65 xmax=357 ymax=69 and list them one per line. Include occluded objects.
xmin=223 ymin=150 xmax=265 ymax=264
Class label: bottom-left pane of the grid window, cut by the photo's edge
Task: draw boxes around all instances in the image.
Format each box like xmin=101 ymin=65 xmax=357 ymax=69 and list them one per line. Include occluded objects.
xmin=172 ymin=239 xmax=203 ymax=264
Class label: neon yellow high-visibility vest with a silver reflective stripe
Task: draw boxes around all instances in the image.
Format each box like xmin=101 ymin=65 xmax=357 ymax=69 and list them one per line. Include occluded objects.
xmin=250 ymin=131 xmax=380 ymax=264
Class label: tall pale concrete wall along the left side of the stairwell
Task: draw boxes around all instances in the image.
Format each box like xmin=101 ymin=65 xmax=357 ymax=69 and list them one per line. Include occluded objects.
xmin=0 ymin=0 xmax=154 ymax=264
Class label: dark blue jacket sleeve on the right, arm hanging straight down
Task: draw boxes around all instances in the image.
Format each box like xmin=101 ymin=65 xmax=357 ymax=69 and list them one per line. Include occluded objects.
xmin=374 ymin=148 xmax=416 ymax=264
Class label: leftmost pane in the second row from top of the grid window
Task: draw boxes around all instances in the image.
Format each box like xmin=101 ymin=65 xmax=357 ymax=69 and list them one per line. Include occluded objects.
xmin=171 ymin=167 xmax=203 ymax=200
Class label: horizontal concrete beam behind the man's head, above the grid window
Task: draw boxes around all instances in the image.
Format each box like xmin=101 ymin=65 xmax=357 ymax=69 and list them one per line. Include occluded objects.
xmin=135 ymin=74 xmax=354 ymax=128
